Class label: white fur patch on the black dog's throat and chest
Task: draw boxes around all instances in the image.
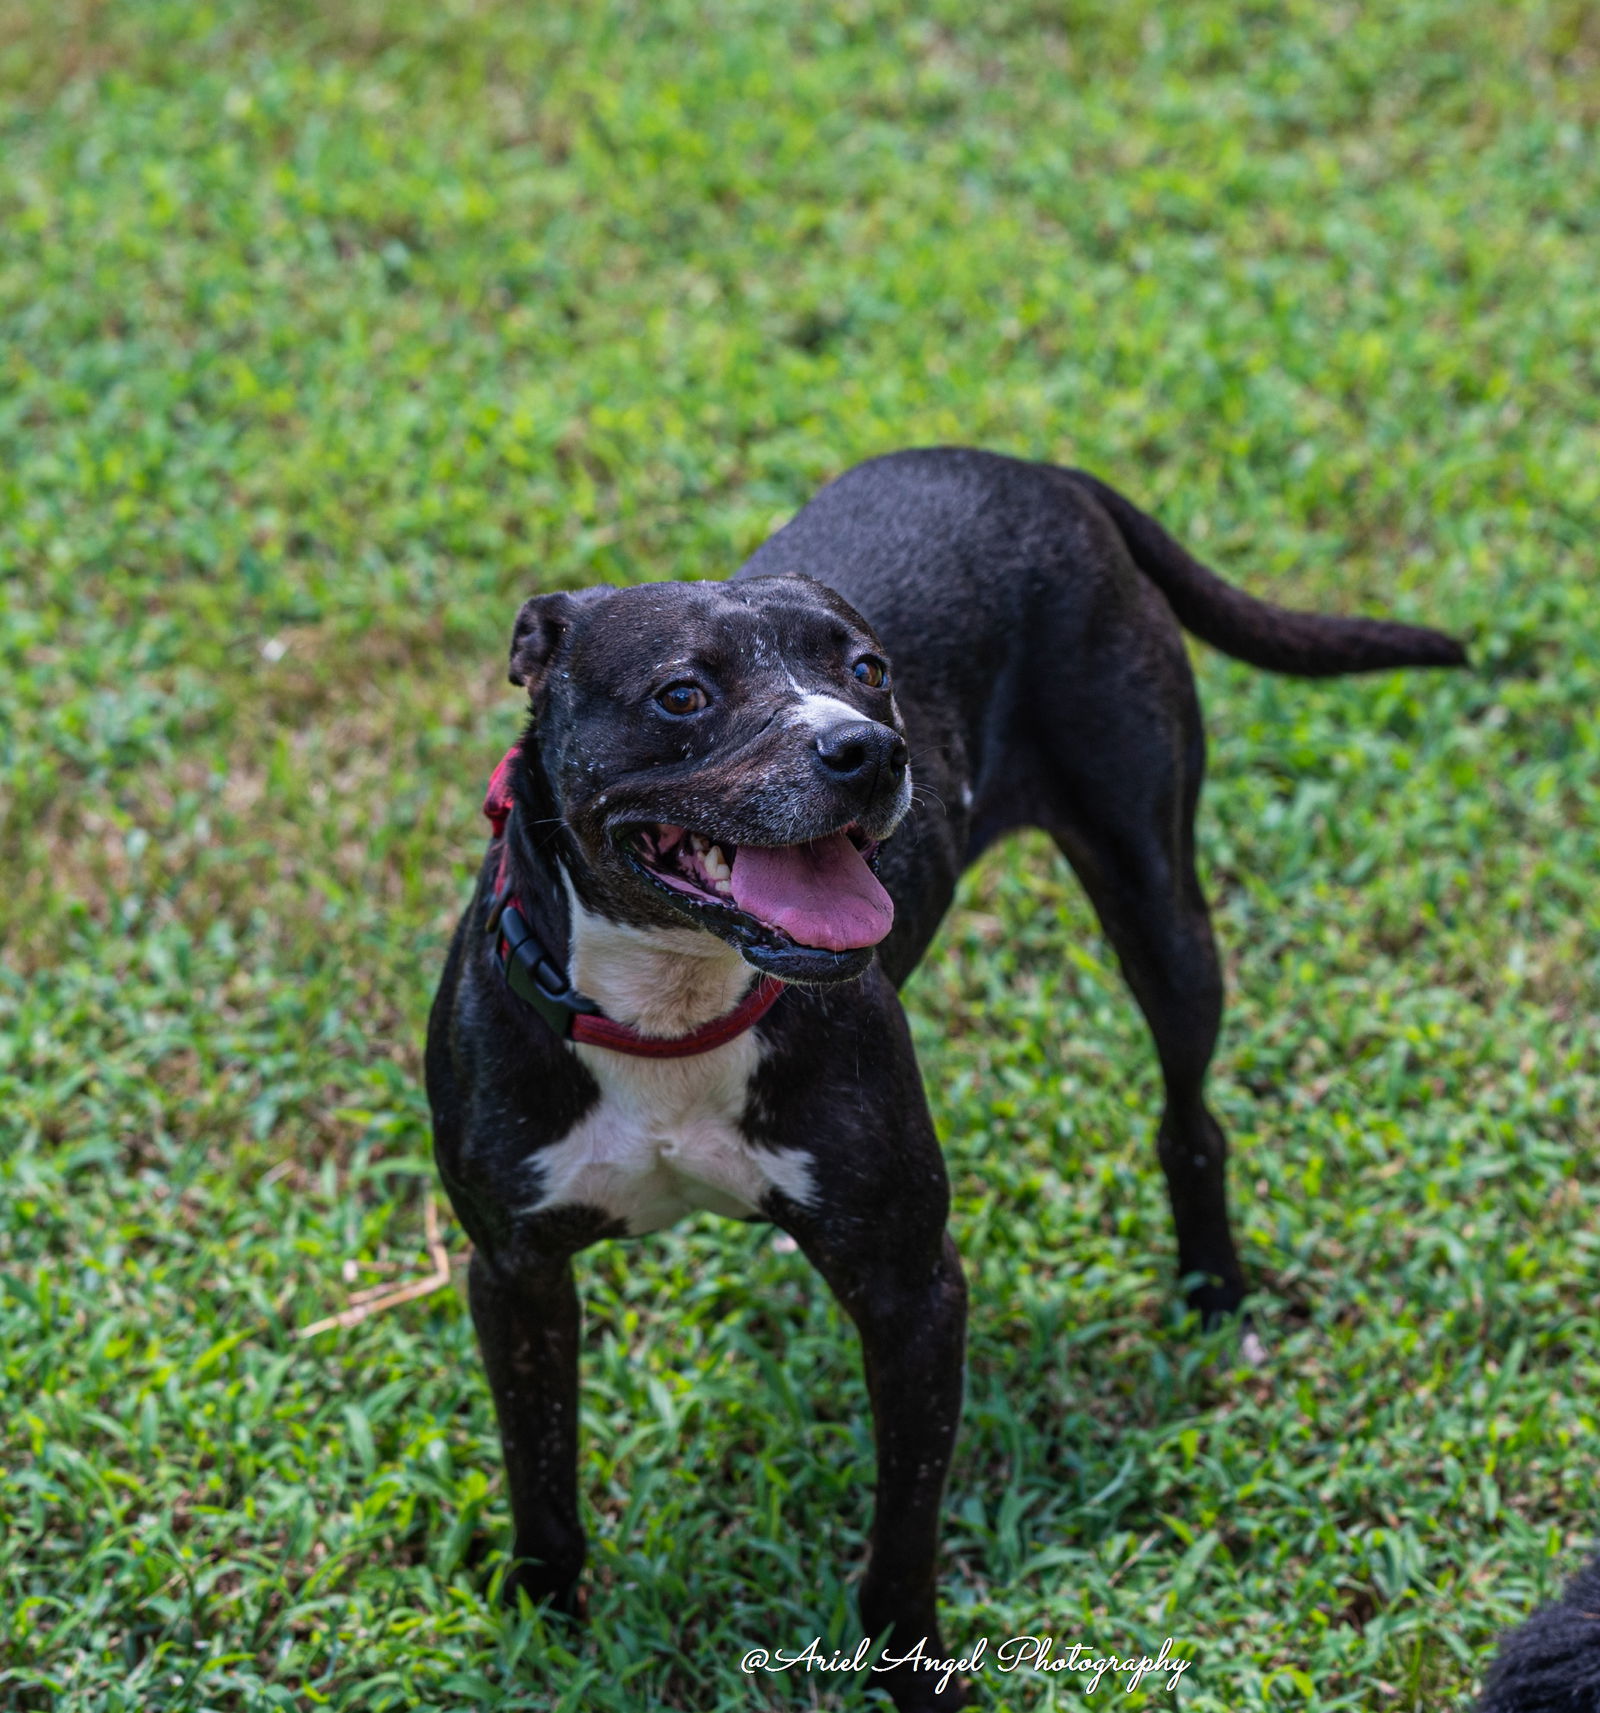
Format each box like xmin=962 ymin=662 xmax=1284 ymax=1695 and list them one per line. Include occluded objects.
xmin=528 ymin=889 xmax=812 ymax=1235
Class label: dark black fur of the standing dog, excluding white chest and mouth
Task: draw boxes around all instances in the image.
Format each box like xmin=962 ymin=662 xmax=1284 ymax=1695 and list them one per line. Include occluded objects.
xmin=427 ymin=451 xmax=1463 ymax=1708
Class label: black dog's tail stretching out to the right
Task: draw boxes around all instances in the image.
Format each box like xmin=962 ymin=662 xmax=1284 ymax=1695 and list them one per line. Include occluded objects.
xmin=1071 ymin=469 xmax=1466 ymax=678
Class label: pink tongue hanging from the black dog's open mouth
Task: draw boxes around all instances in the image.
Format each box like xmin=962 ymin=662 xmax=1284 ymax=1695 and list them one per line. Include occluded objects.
xmin=730 ymin=833 xmax=894 ymax=952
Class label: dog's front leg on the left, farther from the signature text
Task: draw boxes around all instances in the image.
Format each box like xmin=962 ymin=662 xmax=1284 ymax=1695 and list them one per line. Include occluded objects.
xmin=468 ymin=1252 xmax=586 ymax=1617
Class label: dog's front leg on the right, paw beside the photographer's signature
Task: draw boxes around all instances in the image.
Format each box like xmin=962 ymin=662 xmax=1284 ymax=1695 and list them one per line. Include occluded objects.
xmin=807 ymin=1223 xmax=966 ymax=1713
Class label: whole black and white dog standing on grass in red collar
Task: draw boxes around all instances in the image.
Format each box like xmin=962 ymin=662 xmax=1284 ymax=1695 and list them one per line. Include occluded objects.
xmin=427 ymin=449 xmax=1465 ymax=1710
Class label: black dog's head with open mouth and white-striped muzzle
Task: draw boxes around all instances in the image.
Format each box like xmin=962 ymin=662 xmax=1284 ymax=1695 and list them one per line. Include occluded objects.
xmin=510 ymin=577 xmax=911 ymax=982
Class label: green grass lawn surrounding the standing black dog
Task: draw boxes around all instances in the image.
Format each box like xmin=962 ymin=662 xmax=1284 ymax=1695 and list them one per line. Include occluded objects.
xmin=0 ymin=0 xmax=1600 ymax=1713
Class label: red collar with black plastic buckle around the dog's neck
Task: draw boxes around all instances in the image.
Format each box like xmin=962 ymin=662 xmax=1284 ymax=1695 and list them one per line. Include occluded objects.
xmin=483 ymin=749 xmax=783 ymax=1059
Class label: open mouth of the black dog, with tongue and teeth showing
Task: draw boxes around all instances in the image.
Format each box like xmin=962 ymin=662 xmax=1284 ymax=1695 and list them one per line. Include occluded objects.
xmin=629 ymin=822 xmax=894 ymax=952
